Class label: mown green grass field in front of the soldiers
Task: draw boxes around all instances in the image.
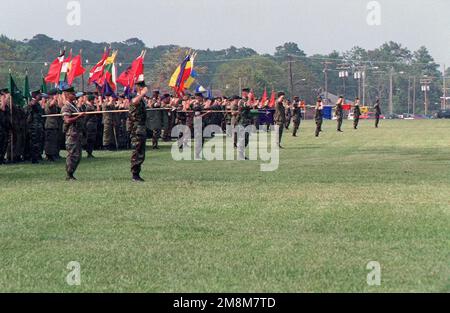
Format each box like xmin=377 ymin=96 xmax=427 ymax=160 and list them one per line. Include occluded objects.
xmin=0 ymin=120 xmax=450 ymax=292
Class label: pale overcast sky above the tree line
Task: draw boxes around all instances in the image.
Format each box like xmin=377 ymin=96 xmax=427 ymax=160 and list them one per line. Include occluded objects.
xmin=0 ymin=0 xmax=450 ymax=67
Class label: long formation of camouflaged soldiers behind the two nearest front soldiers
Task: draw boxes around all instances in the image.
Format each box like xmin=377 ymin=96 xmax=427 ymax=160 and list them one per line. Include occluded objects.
xmin=0 ymin=83 xmax=381 ymax=164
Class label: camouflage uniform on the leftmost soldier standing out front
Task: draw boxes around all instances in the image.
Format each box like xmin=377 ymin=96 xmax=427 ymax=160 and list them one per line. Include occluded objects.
xmin=61 ymin=102 xmax=83 ymax=176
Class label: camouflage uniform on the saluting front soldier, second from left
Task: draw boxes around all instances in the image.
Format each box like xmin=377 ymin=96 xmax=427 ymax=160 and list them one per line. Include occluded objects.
xmin=128 ymin=100 xmax=147 ymax=176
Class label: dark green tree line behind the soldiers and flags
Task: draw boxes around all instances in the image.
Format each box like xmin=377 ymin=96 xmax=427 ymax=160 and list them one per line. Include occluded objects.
xmin=0 ymin=34 xmax=444 ymax=113
